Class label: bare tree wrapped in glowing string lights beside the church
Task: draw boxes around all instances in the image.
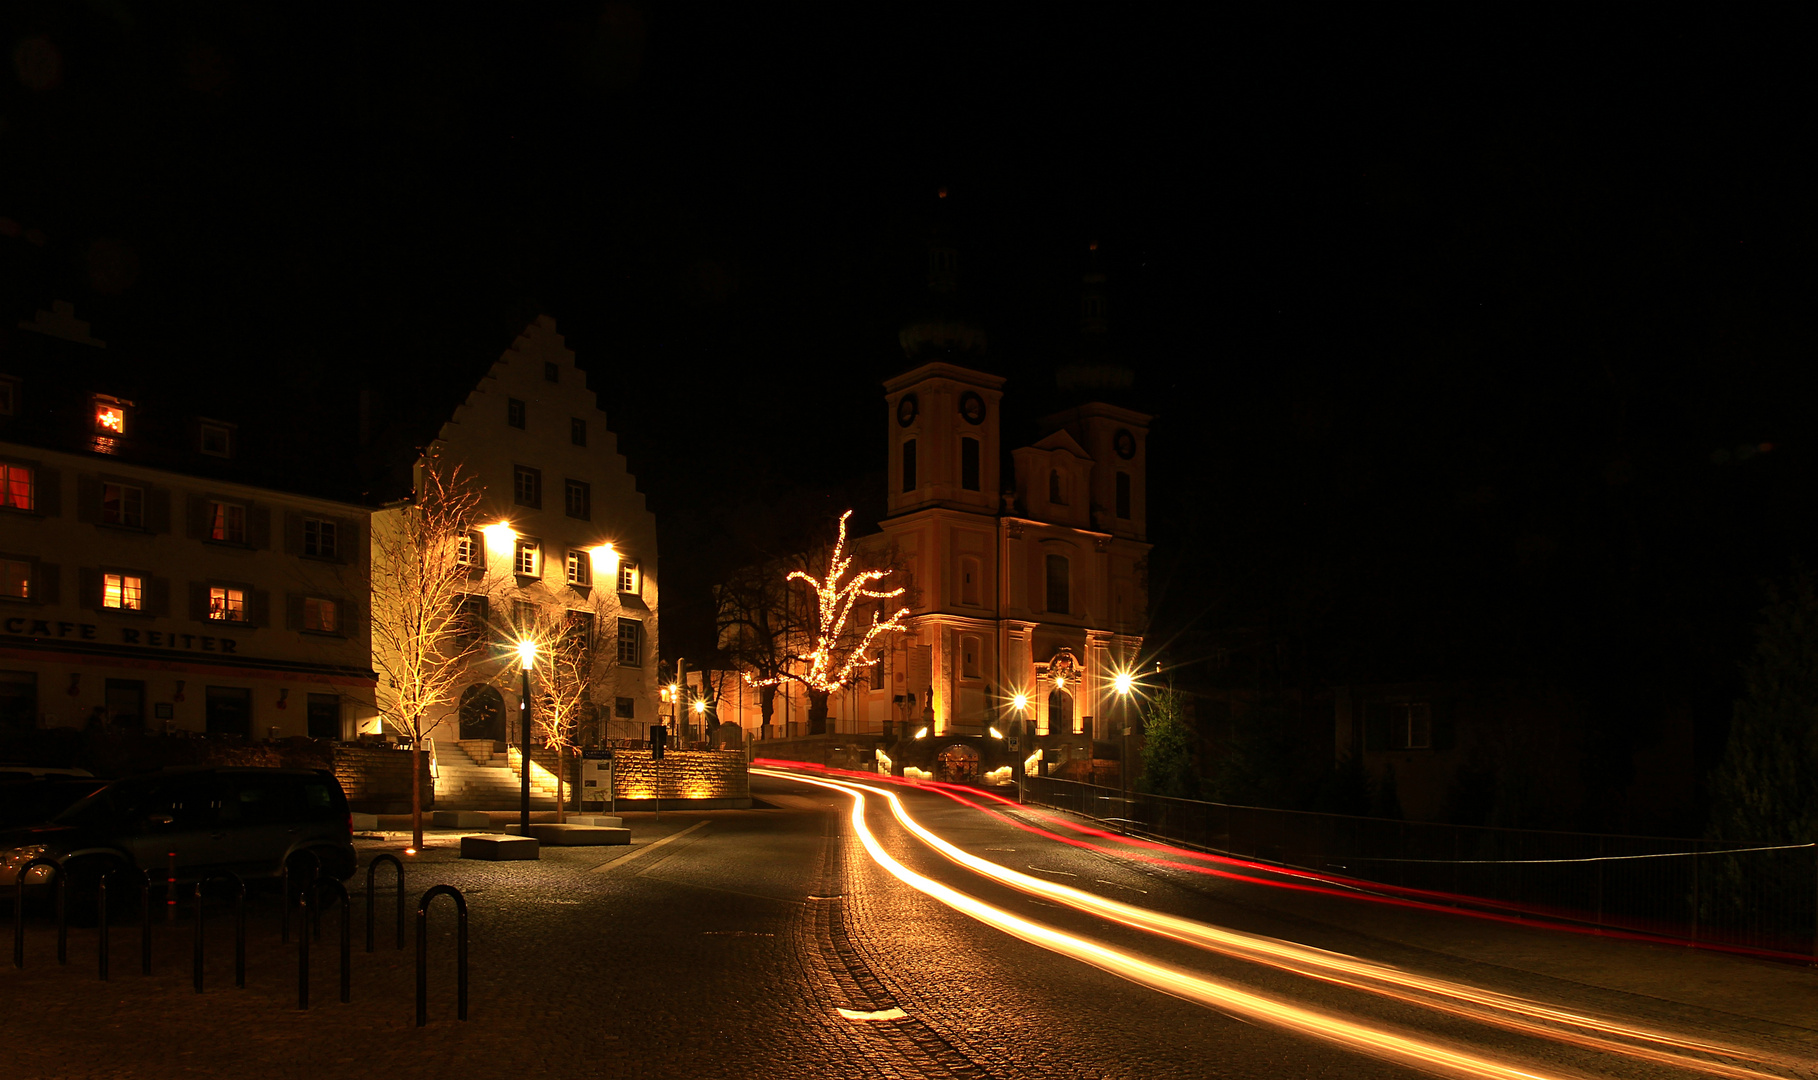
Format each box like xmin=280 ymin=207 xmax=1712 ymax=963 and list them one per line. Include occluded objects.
xmin=745 ymin=511 xmax=909 ymax=735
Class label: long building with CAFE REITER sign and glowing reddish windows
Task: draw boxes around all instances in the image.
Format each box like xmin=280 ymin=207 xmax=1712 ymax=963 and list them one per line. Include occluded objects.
xmin=0 ymin=302 xmax=376 ymax=738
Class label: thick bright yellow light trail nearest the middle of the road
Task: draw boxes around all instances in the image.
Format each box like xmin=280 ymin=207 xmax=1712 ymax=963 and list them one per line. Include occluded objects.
xmin=753 ymin=769 xmax=1562 ymax=1080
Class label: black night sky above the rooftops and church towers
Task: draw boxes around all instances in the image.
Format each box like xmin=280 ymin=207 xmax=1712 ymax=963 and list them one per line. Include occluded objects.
xmin=0 ymin=2 xmax=1818 ymax=800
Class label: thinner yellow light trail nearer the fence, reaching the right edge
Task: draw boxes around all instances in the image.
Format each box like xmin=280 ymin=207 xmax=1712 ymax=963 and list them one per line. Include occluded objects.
xmin=754 ymin=769 xmax=1811 ymax=1080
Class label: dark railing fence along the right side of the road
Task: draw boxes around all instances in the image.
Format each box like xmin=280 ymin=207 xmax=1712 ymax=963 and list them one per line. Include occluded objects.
xmin=1024 ymin=776 xmax=1818 ymax=956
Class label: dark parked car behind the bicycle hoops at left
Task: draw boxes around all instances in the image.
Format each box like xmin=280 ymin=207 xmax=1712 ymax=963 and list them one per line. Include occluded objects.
xmin=0 ymin=767 xmax=355 ymax=898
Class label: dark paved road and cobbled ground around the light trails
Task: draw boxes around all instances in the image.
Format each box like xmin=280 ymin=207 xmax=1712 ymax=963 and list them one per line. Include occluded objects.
xmin=0 ymin=763 xmax=1818 ymax=1080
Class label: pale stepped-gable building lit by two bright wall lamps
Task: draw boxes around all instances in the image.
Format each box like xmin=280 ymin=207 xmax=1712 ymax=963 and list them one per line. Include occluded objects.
xmin=375 ymin=316 xmax=658 ymax=773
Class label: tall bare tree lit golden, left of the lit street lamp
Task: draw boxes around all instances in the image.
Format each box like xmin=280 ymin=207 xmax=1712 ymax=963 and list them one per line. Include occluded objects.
xmin=373 ymin=453 xmax=484 ymax=849
